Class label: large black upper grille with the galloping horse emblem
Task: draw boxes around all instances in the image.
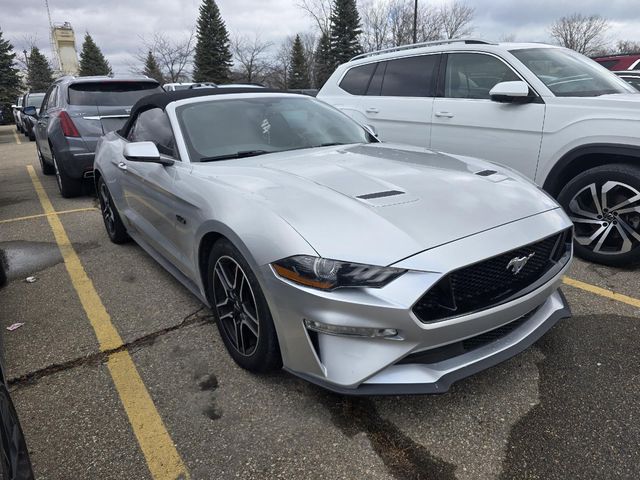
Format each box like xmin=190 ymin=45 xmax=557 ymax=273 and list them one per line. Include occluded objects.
xmin=413 ymin=229 xmax=572 ymax=323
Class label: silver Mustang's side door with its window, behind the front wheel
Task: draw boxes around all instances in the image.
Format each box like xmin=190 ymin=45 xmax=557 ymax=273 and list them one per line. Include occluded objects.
xmin=119 ymin=108 xmax=185 ymax=265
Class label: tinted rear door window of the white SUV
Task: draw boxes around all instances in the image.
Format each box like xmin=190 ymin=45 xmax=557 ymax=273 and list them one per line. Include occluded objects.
xmin=381 ymin=55 xmax=440 ymax=97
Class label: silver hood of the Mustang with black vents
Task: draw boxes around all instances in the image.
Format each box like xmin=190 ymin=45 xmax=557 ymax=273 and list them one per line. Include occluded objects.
xmin=198 ymin=144 xmax=558 ymax=265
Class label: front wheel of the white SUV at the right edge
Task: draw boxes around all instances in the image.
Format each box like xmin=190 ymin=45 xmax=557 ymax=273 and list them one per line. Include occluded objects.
xmin=558 ymin=164 xmax=640 ymax=267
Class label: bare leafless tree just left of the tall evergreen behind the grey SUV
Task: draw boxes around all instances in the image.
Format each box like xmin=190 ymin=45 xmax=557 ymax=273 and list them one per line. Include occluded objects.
xmin=138 ymin=29 xmax=195 ymax=83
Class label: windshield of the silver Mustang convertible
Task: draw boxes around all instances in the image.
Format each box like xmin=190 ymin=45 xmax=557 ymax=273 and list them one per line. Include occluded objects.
xmin=176 ymin=96 xmax=375 ymax=161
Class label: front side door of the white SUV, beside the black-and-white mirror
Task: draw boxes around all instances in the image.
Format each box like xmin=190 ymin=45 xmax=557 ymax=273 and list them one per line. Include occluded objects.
xmin=431 ymin=52 xmax=545 ymax=178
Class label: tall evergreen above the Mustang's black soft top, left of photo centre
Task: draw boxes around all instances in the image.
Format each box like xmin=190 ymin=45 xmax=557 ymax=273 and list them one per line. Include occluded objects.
xmin=193 ymin=0 xmax=232 ymax=83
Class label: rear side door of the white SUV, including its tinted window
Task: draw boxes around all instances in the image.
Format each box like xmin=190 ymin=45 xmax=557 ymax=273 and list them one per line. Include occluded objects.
xmin=359 ymin=53 xmax=440 ymax=147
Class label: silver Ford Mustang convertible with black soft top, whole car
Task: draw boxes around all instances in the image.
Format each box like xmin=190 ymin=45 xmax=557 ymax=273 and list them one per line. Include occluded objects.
xmin=94 ymin=89 xmax=572 ymax=394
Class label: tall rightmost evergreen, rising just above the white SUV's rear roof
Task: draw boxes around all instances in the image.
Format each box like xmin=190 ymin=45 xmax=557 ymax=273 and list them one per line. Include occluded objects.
xmin=331 ymin=0 xmax=362 ymax=67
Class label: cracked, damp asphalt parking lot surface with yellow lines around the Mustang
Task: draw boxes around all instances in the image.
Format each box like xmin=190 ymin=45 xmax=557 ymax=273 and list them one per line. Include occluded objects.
xmin=0 ymin=126 xmax=640 ymax=480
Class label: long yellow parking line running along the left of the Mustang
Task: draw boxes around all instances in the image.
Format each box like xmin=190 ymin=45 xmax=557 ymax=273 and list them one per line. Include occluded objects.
xmin=27 ymin=165 xmax=189 ymax=480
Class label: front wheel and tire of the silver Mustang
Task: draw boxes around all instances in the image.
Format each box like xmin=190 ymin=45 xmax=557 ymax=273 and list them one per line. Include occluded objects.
xmin=207 ymin=239 xmax=282 ymax=373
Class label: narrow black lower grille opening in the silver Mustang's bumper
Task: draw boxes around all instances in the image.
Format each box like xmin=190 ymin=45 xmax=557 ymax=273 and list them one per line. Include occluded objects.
xmin=398 ymin=309 xmax=537 ymax=364
